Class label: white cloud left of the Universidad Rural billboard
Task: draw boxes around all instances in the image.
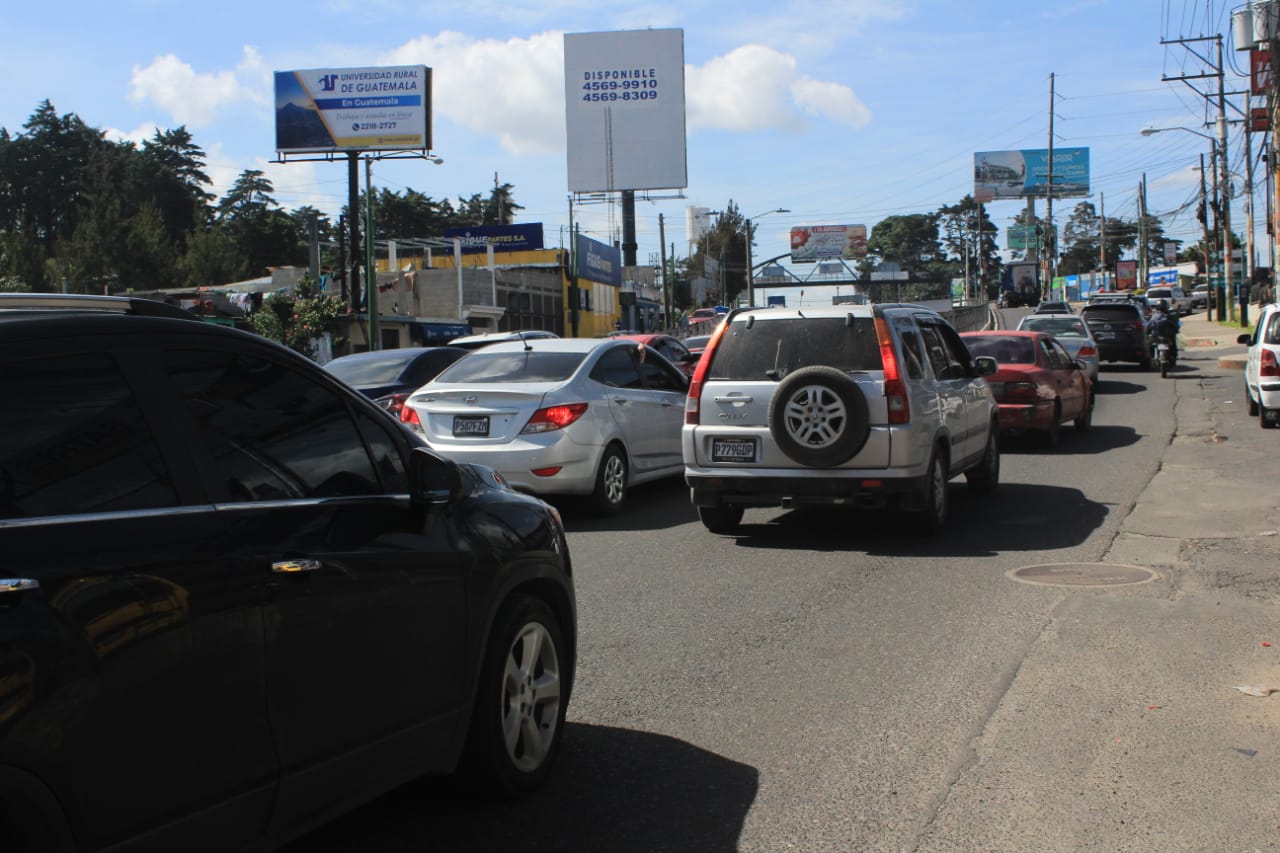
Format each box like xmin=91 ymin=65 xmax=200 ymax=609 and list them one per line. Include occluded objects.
xmin=129 ymin=47 xmax=270 ymax=128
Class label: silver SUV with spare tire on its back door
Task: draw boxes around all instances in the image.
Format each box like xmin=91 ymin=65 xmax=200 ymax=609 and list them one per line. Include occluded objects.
xmin=682 ymin=305 xmax=1000 ymax=533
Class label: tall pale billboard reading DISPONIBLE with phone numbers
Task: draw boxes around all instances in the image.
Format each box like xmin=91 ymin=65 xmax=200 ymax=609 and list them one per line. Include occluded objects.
xmin=564 ymin=29 xmax=689 ymax=192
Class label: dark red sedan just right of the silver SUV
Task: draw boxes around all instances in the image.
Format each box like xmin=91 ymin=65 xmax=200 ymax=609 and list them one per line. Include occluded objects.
xmin=960 ymin=330 xmax=1093 ymax=447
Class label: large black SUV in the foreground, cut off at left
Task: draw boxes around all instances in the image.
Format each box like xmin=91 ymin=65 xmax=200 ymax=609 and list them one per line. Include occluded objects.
xmin=0 ymin=295 xmax=577 ymax=852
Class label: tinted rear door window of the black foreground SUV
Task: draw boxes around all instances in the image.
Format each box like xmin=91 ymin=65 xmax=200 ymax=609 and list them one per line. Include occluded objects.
xmin=0 ymin=353 xmax=178 ymax=519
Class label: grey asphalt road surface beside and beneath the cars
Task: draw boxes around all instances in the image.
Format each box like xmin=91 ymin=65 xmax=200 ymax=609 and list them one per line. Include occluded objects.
xmin=282 ymin=315 xmax=1280 ymax=853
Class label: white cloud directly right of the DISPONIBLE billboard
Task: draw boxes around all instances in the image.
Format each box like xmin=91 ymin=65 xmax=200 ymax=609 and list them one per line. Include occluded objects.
xmin=685 ymin=45 xmax=870 ymax=132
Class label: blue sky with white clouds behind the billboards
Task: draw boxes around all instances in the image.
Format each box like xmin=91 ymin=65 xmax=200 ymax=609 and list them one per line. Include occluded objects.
xmin=0 ymin=0 xmax=1270 ymax=279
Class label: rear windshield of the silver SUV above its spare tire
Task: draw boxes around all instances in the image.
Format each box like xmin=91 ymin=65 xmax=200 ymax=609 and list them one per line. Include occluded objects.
xmin=707 ymin=316 xmax=884 ymax=380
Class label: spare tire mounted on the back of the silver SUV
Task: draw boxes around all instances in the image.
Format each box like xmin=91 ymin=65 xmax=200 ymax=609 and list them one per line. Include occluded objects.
xmin=769 ymin=366 xmax=870 ymax=467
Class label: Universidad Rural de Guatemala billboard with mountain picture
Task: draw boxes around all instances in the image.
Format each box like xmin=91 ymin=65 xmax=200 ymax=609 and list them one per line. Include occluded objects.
xmin=275 ymin=65 xmax=431 ymax=154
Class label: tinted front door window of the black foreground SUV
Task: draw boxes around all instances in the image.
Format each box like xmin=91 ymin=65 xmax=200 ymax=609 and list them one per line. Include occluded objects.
xmin=165 ymin=350 xmax=381 ymax=501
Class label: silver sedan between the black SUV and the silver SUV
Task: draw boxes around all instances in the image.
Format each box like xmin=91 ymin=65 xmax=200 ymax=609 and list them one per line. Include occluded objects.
xmin=402 ymin=338 xmax=689 ymax=515
